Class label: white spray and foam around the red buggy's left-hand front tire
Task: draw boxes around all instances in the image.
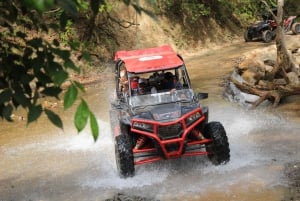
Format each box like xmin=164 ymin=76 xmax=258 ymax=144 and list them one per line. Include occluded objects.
xmin=70 ymin=121 xmax=168 ymax=189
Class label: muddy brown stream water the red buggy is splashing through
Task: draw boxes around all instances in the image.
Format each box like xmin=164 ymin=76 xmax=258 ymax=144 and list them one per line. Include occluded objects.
xmin=0 ymin=38 xmax=300 ymax=201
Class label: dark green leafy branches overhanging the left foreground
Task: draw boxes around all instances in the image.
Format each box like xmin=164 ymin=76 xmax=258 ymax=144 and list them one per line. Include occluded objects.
xmin=0 ymin=0 xmax=99 ymax=140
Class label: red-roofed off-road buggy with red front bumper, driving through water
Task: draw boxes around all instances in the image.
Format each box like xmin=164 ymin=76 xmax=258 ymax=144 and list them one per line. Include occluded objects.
xmin=110 ymin=45 xmax=230 ymax=177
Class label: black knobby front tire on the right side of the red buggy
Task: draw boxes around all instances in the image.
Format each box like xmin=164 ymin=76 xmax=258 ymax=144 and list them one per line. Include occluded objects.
xmin=203 ymin=122 xmax=230 ymax=165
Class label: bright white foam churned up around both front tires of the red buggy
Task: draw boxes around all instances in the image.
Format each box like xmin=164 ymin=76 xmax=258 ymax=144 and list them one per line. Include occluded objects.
xmin=2 ymin=103 xmax=298 ymax=194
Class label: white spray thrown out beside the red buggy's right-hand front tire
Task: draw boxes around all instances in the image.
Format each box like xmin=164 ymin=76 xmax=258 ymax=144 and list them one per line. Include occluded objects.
xmin=190 ymin=106 xmax=296 ymax=183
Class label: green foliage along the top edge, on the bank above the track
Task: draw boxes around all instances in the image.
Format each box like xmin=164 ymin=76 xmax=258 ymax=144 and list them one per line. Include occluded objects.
xmin=157 ymin=0 xmax=284 ymax=28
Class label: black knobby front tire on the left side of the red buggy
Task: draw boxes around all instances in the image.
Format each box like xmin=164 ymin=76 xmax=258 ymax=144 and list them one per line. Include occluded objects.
xmin=115 ymin=134 xmax=135 ymax=178
